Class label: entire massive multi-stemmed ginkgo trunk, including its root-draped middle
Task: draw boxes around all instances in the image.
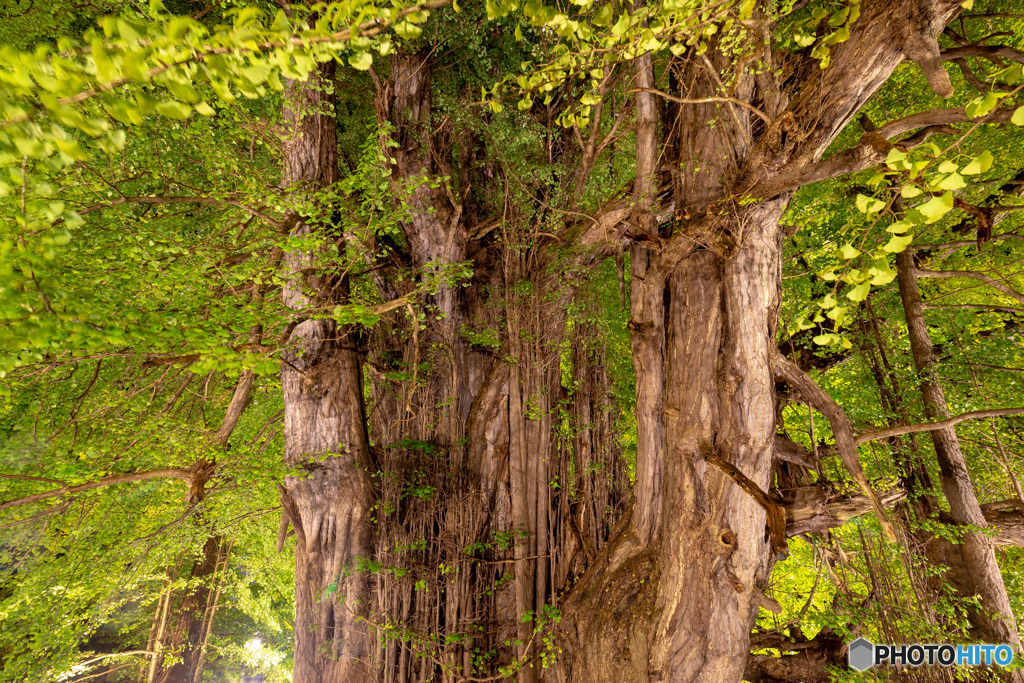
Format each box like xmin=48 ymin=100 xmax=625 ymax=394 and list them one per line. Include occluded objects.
xmin=268 ymin=0 xmax=987 ymax=683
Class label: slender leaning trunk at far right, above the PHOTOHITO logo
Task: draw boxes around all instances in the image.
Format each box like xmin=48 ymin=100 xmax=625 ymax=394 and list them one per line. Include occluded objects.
xmin=896 ymin=249 xmax=1024 ymax=659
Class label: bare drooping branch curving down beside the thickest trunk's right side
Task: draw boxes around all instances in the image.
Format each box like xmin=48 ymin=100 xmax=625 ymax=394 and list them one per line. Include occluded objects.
xmin=772 ymin=349 xmax=896 ymax=543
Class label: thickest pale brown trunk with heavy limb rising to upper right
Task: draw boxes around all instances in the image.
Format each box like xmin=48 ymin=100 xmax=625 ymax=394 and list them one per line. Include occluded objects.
xmin=565 ymin=2 xmax=955 ymax=682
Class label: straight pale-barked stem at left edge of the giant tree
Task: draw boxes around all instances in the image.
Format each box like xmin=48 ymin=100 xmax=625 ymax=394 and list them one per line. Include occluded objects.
xmin=281 ymin=62 xmax=372 ymax=683
